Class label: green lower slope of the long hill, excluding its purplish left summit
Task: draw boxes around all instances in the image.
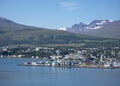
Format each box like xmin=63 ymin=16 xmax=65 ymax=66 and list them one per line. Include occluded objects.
xmin=0 ymin=28 xmax=116 ymax=46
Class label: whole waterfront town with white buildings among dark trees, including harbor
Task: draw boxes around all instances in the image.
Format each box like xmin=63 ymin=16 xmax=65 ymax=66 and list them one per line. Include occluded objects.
xmin=0 ymin=46 xmax=120 ymax=68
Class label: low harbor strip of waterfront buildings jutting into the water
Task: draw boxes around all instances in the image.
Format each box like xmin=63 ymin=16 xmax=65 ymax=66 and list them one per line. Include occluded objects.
xmin=18 ymin=59 xmax=120 ymax=69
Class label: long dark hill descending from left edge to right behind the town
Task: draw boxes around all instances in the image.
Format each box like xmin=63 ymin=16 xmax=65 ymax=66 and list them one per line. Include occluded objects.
xmin=0 ymin=17 xmax=118 ymax=47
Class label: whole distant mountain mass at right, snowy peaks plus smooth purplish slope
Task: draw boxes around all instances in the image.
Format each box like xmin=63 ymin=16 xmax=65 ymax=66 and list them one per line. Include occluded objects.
xmin=60 ymin=20 xmax=120 ymax=39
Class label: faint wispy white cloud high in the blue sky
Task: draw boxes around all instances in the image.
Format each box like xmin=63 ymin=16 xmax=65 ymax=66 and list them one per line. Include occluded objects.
xmin=60 ymin=1 xmax=80 ymax=10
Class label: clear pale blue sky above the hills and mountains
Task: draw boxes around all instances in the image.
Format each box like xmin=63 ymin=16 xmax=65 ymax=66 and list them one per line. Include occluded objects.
xmin=0 ymin=0 xmax=120 ymax=29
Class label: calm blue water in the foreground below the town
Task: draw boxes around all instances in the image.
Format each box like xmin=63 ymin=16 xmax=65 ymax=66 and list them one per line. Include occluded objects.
xmin=0 ymin=58 xmax=120 ymax=86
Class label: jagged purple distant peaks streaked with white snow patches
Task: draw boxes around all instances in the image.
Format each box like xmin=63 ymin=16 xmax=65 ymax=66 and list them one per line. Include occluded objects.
xmin=58 ymin=20 xmax=113 ymax=33
